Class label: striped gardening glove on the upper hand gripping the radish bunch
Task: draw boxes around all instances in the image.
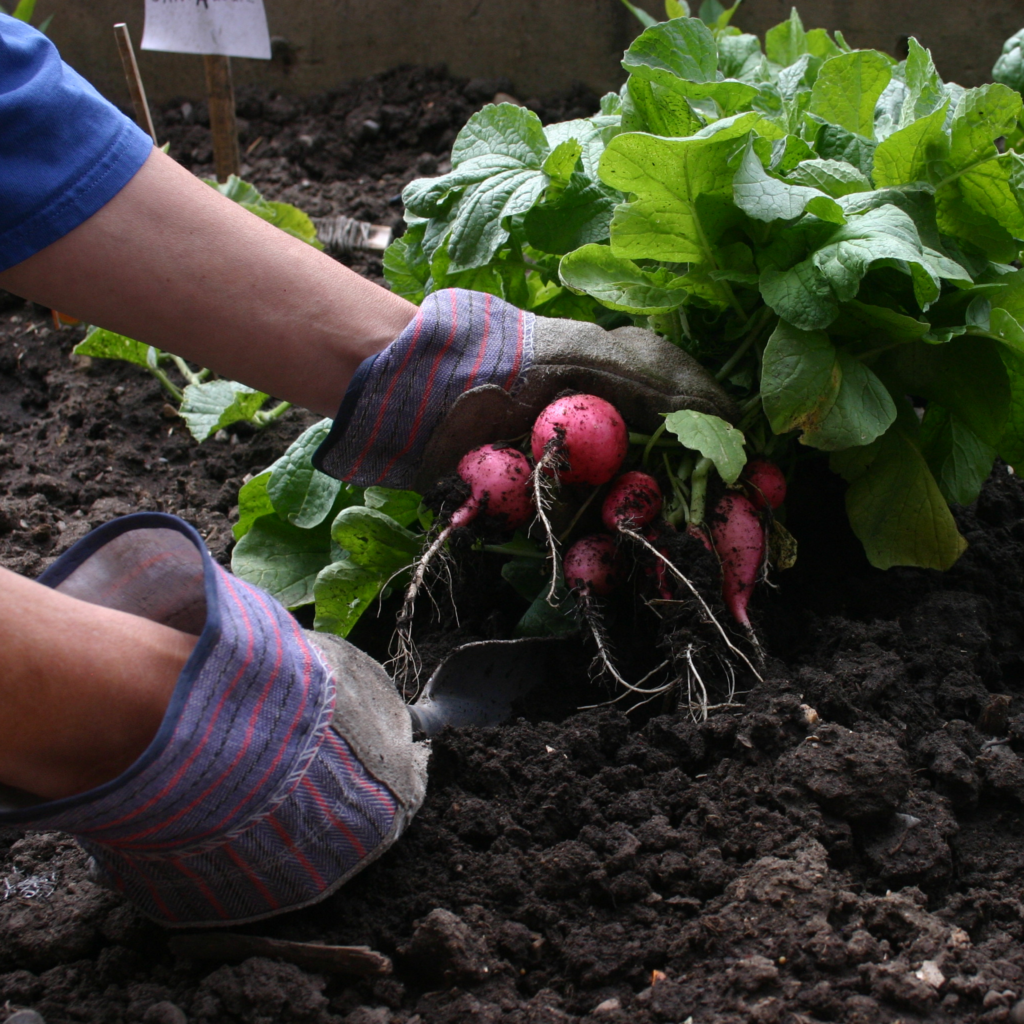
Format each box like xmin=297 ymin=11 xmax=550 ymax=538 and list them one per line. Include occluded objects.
xmin=313 ymin=288 xmax=736 ymax=492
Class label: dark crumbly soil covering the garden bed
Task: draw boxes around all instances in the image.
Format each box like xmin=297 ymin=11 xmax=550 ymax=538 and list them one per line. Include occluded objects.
xmin=6 ymin=72 xmax=1024 ymax=1024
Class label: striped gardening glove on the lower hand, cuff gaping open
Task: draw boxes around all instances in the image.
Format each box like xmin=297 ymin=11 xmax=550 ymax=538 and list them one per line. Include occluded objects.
xmin=0 ymin=513 xmax=427 ymax=927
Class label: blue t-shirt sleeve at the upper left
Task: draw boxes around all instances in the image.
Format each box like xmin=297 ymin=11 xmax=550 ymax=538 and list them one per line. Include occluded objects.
xmin=0 ymin=14 xmax=153 ymax=270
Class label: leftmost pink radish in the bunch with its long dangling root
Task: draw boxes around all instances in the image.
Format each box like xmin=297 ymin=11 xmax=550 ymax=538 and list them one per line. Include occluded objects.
xmin=395 ymin=444 xmax=534 ymax=673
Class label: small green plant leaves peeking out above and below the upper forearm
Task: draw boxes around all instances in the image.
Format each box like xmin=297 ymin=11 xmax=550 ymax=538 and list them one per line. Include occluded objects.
xmin=75 ymin=174 xmax=324 ymax=441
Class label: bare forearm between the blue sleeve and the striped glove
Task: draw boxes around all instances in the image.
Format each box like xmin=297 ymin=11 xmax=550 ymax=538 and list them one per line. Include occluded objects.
xmin=0 ymin=150 xmax=416 ymax=415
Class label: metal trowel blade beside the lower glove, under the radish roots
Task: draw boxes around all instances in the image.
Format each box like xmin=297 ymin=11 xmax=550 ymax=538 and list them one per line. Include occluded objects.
xmin=409 ymin=637 xmax=559 ymax=736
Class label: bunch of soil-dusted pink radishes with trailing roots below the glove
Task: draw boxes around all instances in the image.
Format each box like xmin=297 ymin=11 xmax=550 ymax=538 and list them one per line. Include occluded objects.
xmin=399 ymin=394 xmax=785 ymax=689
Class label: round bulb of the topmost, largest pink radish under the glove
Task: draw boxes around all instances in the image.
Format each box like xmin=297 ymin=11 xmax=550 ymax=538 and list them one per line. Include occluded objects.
xmin=530 ymin=394 xmax=630 ymax=486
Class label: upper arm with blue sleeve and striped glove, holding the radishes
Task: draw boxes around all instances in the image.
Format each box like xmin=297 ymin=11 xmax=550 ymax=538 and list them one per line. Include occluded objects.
xmin=0 ymin=9 xmax=729 ymax=489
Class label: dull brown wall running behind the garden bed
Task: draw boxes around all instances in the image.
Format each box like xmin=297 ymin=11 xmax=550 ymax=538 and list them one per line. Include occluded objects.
xmin=37 ymin=0 xmax=1024 ymax=103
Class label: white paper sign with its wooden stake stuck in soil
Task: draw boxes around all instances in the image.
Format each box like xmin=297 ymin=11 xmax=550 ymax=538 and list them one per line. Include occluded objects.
xmin=142 ymin=0 xmax=270 ymax=181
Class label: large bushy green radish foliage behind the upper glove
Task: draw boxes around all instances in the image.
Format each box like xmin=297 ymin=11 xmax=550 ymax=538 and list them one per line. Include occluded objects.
xmin=376 ymin=4 xmax=1024 ymax=568
